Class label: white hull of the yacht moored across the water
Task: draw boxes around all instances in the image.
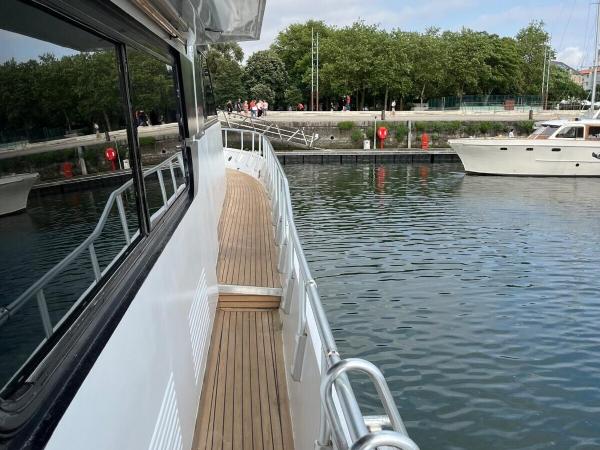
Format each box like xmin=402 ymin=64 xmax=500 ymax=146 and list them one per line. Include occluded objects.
xmin=449 ymin=139 xmax=600 ymax=177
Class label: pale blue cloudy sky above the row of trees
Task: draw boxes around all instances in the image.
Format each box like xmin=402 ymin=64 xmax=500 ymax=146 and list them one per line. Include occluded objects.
xmin=242 ymin=0 xmax=596 ymax=68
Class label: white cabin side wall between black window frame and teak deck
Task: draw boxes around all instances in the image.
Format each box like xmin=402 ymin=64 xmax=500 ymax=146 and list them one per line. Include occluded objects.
xmin=46 ymin=124 xmax=225 ymax=450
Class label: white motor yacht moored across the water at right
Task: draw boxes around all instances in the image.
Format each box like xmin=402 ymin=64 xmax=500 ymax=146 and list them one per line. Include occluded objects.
xmin=449 ymin=119 xmax=600 ymax=177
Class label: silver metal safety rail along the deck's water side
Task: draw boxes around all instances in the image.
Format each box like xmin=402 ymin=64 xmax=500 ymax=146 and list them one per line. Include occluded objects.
xmin=223 ymin=128 xmax=419 ymax=450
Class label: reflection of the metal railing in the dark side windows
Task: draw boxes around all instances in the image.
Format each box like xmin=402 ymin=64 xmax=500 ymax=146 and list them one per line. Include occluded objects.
xmin=0 ymin=152 xmax=185 ymax=339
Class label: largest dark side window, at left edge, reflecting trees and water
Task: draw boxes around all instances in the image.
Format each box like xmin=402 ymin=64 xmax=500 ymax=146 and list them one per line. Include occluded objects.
xmin=0 ymin=0 xmax=139 ymax=389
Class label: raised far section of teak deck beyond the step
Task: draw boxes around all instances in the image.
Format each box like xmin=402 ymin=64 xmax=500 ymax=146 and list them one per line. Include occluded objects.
xmin=217 ymin=170 xmax=281 ymax=288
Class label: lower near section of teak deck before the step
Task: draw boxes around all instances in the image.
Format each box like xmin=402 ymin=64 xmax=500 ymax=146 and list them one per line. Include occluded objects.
xmin=193 ymin=308 xmax=293 ymax=450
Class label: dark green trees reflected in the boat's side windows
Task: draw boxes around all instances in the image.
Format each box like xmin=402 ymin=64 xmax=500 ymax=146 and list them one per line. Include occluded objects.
xmin=0 ymin=47 xmax=176 ymax=141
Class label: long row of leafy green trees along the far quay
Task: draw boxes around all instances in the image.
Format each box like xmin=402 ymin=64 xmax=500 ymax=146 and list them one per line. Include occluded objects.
xmin=271 ymin=21 xmax=584 ymax=108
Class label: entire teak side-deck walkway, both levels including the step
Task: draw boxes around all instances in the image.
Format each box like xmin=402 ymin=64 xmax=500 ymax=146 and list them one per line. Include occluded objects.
xmin=192 ymin=170 xmax=294 ymax=450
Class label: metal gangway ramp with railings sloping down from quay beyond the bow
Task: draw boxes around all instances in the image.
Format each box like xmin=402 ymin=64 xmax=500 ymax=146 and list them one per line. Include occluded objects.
xmin=218 ymin=111 xmax=319 ymax=150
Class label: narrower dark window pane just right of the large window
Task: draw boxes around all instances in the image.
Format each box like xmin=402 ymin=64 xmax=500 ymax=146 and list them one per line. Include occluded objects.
xmin=127 ymin=47 xmax=186 ymax=227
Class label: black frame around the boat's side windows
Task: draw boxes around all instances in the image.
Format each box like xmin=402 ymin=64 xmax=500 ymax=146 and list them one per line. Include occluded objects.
xmin=0 ymin=0 xmax=201 ymax=448
